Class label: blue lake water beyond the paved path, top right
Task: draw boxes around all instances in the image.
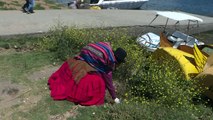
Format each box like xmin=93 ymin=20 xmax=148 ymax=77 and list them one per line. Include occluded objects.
xmin=141 ymin=0 xmax=213 ymax=17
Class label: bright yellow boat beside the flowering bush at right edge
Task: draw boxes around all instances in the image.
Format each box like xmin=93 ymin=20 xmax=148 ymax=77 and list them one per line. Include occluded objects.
xmin=153 ymin=33 xmax=213 ymax=99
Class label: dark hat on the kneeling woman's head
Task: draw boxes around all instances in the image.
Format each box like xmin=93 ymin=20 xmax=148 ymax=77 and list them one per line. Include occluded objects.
xmin=114 ymin=48 xmax=127 ymax=63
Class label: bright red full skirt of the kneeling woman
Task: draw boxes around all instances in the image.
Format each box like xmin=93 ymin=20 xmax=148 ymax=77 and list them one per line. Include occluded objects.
xmin=48 ymin=62 xmax=105 ymax=106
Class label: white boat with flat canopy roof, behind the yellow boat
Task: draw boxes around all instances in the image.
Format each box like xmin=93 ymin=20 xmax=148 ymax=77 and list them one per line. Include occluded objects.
xmin=136 ymin=11 xmax=204 ymax=52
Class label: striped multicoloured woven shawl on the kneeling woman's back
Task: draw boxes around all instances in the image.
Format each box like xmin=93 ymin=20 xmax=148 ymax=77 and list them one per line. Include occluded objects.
xmin=76 ymin=42 xmax=116 ymax=73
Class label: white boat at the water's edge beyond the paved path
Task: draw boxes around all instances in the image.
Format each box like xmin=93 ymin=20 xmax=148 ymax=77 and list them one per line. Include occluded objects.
xmin=90 ymin=0 xmax=148 ymax=9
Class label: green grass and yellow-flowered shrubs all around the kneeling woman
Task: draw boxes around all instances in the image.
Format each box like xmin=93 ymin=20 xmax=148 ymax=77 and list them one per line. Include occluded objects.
xmin=0 ymin=26 xmax=213 ymax=120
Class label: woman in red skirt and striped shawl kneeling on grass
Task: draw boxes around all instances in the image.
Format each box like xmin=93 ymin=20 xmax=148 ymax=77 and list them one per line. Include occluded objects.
xmin=48 ymin=42 xmax=127 ymax=106
